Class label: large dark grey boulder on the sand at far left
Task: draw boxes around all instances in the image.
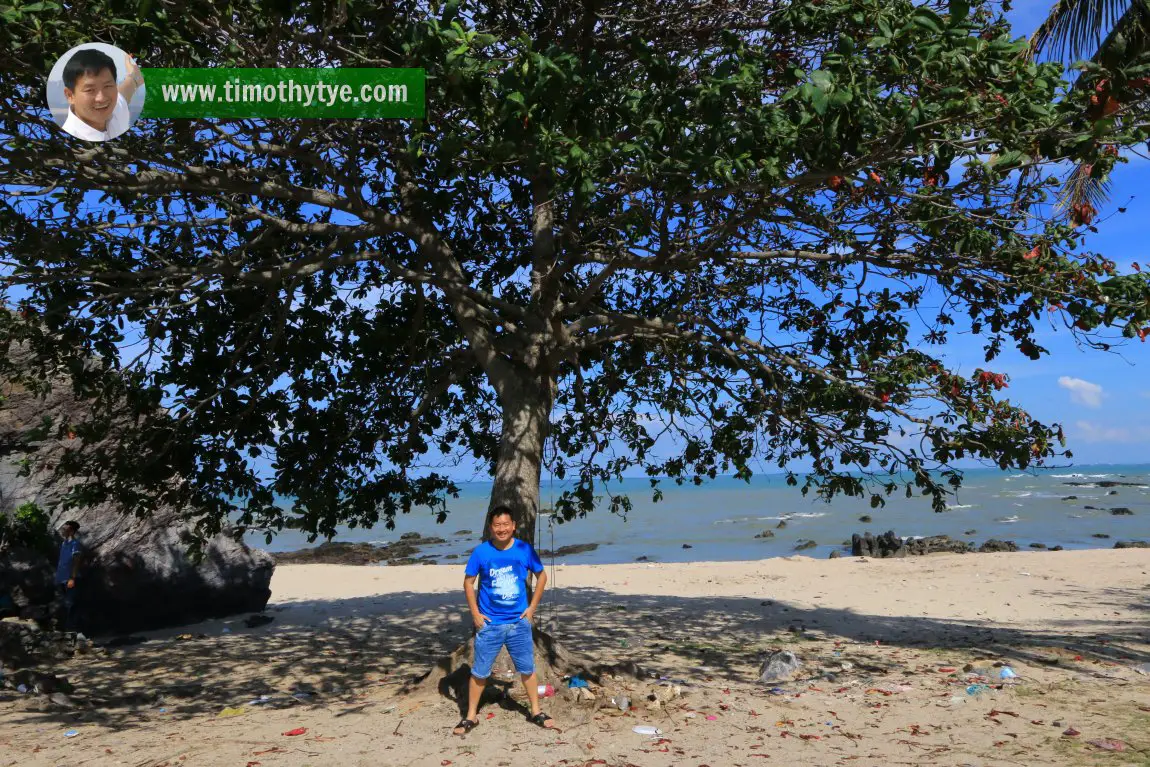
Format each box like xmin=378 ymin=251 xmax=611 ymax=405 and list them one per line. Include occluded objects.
xmin=0 ymin=351 xmax=275 ymax=632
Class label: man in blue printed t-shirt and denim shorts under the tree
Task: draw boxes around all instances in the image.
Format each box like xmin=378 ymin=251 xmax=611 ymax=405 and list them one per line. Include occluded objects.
xmin=454 ymin=506 xmax=554 ymax=735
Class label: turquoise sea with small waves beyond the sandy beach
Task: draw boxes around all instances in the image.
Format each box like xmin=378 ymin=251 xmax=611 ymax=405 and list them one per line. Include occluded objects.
xmin=250 ymin=463 xmax=1150 ymax=563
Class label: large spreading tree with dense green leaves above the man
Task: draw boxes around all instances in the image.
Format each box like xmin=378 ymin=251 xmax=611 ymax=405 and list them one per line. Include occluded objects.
xmin=0 ymin=0 xmax=1150 ymax=545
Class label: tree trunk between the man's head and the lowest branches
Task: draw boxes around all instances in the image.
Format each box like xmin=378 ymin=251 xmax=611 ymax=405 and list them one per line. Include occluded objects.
xmin=483 ymin=378 xmax=554 ymax=545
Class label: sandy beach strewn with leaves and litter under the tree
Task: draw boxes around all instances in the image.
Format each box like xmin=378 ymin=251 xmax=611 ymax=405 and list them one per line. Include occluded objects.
xmin=0 ymin=550 xmax=1150 ymax=767
